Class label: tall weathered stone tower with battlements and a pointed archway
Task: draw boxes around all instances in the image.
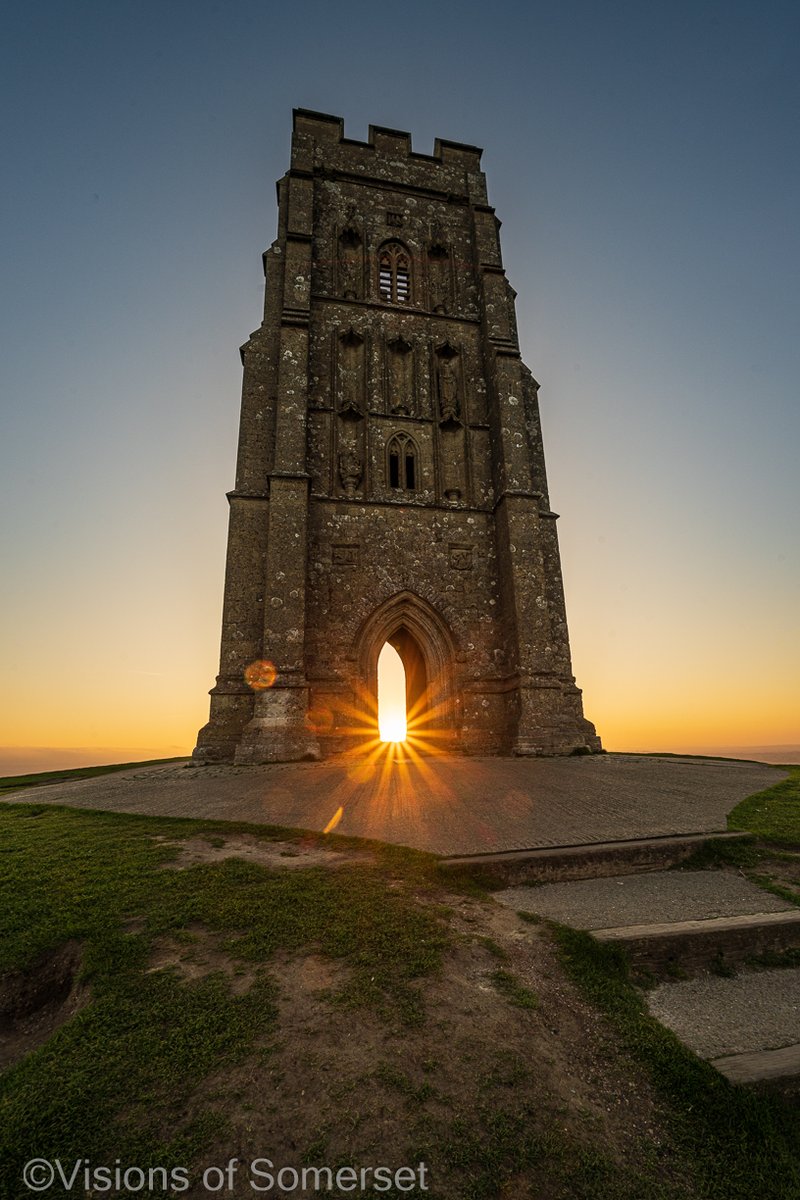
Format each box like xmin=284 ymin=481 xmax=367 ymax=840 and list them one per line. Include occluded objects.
xmin=194 ymin=109 xmax=600 ymax=763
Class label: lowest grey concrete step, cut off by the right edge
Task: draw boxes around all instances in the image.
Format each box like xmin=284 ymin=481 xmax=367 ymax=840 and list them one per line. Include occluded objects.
xmin=648 ymin=967 xmax=800 ymax=1091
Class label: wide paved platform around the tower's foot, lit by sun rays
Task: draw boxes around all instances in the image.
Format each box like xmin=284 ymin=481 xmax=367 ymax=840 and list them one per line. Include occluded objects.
xmin=5 ymin=752 xmax=787 ymax=856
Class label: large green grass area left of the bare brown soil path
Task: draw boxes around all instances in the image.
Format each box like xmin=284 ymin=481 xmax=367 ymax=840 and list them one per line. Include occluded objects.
xmin=0 ymin=803 xmax=447 ymax=1180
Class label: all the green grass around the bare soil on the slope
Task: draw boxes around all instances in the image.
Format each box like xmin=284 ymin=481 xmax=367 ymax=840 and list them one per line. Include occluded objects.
xmin=0 ymin=764 xmax=800 ymax=1200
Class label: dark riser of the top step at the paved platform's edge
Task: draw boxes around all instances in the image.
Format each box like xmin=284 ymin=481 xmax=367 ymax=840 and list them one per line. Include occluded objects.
xmin=441 ymin=830 xmax=748 ymax=889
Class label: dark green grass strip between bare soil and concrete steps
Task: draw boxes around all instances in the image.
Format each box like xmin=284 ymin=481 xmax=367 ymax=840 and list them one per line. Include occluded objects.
xmin=553 ymin=926 xmax=800 ymax=1200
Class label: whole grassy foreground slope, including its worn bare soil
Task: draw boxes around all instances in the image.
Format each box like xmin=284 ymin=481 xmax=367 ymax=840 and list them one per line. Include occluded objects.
xmin=0 ymin=773 xmax=800 ymax=1200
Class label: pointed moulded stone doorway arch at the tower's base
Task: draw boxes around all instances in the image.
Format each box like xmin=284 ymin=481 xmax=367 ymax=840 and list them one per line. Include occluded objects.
xmin=354 ymin=592 xmax=458 ymax=749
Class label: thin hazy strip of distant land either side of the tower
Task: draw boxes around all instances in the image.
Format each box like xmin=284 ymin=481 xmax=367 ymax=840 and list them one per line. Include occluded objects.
xmin=0 ymin=743 xmax=800 ymax=778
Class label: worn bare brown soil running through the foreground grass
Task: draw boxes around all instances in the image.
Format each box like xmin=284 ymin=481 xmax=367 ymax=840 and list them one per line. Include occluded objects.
xmin=150 ymin=859 xmax=692 ymax=1200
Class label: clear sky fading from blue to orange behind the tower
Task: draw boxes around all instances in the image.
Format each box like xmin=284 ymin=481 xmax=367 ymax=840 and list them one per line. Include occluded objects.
xmin=0 ymin=0 xmax=800 ymax=762
